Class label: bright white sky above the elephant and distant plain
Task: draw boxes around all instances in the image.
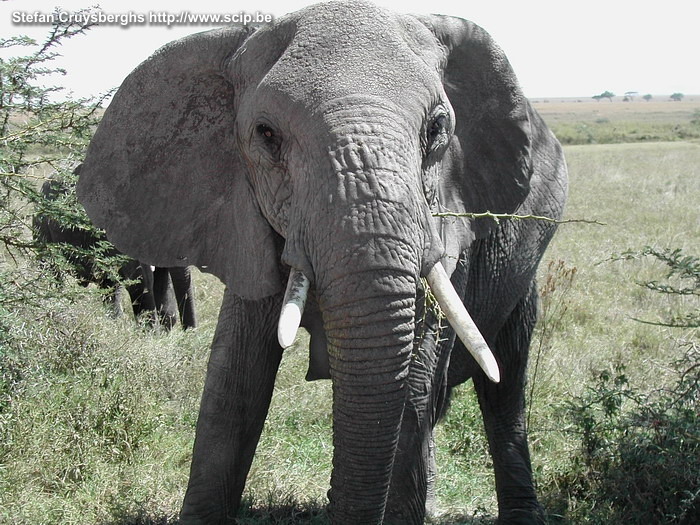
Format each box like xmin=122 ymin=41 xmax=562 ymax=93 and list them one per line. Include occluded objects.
xmin=0 ymin=0 xmax=700 ymax=99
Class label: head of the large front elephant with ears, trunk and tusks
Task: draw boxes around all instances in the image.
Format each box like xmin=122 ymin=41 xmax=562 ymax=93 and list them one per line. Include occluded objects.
xmin=79 ymin=2 xmax=530 ymax=518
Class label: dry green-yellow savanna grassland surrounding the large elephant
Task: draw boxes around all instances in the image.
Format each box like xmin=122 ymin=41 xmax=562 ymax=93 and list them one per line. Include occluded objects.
xmin=0 ymin=90 xmax=700 ymax=525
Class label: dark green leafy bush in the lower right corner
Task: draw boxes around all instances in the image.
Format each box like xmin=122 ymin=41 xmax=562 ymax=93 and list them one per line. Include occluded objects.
xmin=550 ymin=247 xmax=700 ymax=524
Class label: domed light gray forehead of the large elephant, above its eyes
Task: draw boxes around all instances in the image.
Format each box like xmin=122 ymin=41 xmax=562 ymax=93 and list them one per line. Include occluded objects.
xmin=265 ymin=2 xmax=438 ymax=110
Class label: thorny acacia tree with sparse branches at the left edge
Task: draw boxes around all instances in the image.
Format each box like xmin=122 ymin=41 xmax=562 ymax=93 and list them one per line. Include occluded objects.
xmin=0 ymin=17 xmax=116 ymax=320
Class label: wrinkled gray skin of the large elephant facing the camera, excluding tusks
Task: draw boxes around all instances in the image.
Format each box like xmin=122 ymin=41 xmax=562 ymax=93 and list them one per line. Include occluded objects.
xmin=78 ymin=2 xmax=566 ymax=524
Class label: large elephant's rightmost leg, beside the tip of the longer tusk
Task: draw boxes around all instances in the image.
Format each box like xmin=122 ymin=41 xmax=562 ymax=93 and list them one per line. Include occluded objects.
xmin=474 ymin=281 xmax=544 ymax=524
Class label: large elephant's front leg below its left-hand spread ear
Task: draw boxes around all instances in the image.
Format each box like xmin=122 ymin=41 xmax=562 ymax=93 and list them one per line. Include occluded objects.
xmin=180 ymin=291 xmax=282 ymax=525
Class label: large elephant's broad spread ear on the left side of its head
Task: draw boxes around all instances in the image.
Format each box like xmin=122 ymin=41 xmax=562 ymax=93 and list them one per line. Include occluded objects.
xmin=78 ymin=27 xmax=283 ymax=299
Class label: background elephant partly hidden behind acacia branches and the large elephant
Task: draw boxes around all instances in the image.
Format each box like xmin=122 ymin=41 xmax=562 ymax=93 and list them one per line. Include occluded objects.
xmin=37 ymin=170 xmax=197 ymax=330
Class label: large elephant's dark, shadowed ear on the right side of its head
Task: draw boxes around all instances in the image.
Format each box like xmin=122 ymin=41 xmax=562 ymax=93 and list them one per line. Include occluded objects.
xmin=417 ymin=15 xmax=532 ymax=236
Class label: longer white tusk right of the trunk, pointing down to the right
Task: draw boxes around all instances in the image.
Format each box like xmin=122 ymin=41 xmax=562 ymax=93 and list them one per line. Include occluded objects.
xmin=427 ymin=263 xmax=501 ymax=383
